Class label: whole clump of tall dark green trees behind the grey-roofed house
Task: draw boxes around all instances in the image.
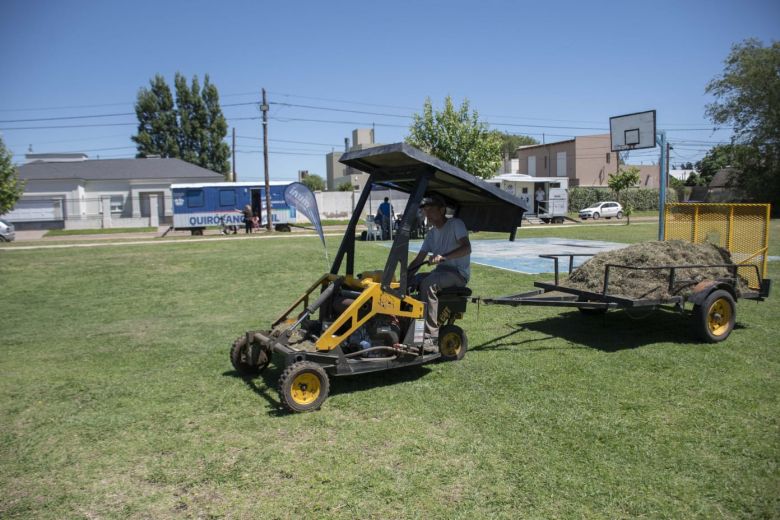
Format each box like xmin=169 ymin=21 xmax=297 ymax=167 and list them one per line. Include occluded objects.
xmin=132 ymin=73 xmax=230 ymax=179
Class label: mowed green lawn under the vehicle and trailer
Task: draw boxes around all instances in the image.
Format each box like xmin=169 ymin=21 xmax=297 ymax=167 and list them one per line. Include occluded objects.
xmin=0 ymin=222 xmax=780 ymax=519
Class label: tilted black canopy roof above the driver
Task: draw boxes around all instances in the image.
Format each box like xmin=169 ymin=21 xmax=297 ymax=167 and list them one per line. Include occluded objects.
xmin=340 ymin=143 xmax=526 ymax=233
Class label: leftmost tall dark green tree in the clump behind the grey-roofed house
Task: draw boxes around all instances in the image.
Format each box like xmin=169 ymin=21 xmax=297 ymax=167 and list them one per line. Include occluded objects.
xmin=131 ymin=74 xmax=180 ymax=157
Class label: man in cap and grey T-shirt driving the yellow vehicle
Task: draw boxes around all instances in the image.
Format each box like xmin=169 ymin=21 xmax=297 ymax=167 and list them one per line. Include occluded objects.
xmin=409 ymin=194 xmax=471 ymax=346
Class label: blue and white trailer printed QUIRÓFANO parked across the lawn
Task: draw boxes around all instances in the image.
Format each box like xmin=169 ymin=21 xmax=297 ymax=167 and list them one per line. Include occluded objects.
xmin=171 ymin=181 xmax=297 ymax=235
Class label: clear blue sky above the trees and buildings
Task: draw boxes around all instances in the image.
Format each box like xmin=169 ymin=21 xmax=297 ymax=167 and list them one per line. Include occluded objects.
xmin=0 ymin=0 xmax=780 ymax=181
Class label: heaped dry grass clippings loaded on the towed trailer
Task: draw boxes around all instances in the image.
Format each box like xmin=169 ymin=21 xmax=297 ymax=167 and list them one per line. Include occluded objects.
xmin=561 ymin=240 xmax=741 ymax=300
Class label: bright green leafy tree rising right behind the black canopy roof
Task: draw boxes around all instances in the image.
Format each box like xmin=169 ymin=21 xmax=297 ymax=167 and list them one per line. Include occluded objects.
xmin=406 ymin=96 xmax=501 ymax=179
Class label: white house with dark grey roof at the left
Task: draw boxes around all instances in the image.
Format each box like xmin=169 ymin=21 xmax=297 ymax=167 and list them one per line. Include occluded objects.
xmin=3 ymin=154 xmax=224 ymax=229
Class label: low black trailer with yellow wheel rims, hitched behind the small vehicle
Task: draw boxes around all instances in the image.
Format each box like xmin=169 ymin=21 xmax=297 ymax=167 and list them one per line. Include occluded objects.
xmin=472 ymin=254 xmax=772 ymax=343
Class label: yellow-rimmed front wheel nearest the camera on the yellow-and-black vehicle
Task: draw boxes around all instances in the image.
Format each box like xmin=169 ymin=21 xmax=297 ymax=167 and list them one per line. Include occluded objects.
xmin=279 ymin=361 xmax=330 ymax=412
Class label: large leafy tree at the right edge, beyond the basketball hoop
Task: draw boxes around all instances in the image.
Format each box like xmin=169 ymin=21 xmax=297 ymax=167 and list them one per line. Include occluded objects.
xmin=706 ymin=39 xmax=780 ymax=209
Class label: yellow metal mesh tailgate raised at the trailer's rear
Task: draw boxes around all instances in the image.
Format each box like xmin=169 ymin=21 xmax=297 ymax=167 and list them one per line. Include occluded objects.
xmin=664 ymin=203 xmax=770 ymax=289
